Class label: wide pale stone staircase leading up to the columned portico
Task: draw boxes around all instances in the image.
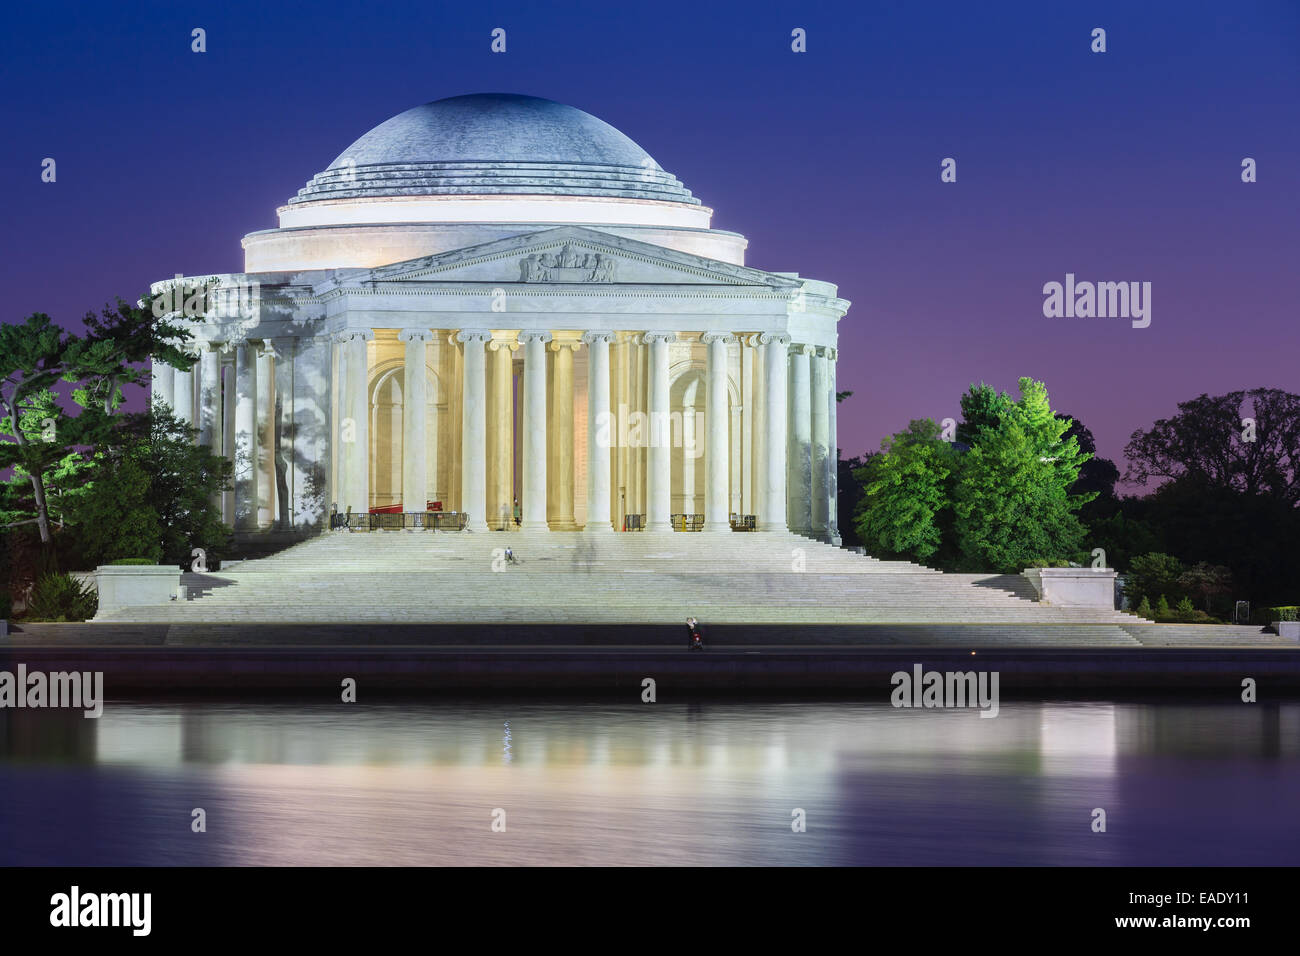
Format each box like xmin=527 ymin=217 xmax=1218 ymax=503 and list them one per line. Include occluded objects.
xmin=89 ymin=531 xmax=1141 ymax=646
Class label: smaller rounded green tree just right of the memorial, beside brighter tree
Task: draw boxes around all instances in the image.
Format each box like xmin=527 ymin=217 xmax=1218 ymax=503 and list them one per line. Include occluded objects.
xmin=854 ymin=419 xmax=953 ymax=562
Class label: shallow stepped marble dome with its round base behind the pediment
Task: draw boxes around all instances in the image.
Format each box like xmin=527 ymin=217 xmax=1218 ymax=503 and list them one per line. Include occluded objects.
xmin=243 ymin=92 xmax=748 ymax=273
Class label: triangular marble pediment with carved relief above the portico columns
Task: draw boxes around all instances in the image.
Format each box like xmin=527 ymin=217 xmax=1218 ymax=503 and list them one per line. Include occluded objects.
xmin=322 ymin=226 xmax=801 ymax=290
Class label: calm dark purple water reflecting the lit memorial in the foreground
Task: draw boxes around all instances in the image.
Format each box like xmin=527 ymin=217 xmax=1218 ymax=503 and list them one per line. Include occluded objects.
xmin=0 ymin=702 xmax=1300 ymax=865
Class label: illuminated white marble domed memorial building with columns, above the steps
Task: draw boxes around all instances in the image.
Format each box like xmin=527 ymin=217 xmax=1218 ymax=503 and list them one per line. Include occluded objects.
xmin=153 ymin=94 xmax=849 ymax=541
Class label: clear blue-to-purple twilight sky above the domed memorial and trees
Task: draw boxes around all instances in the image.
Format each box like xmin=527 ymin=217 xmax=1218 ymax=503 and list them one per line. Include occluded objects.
xmin=0 ymin=0 xmax=1300 ymax=478
